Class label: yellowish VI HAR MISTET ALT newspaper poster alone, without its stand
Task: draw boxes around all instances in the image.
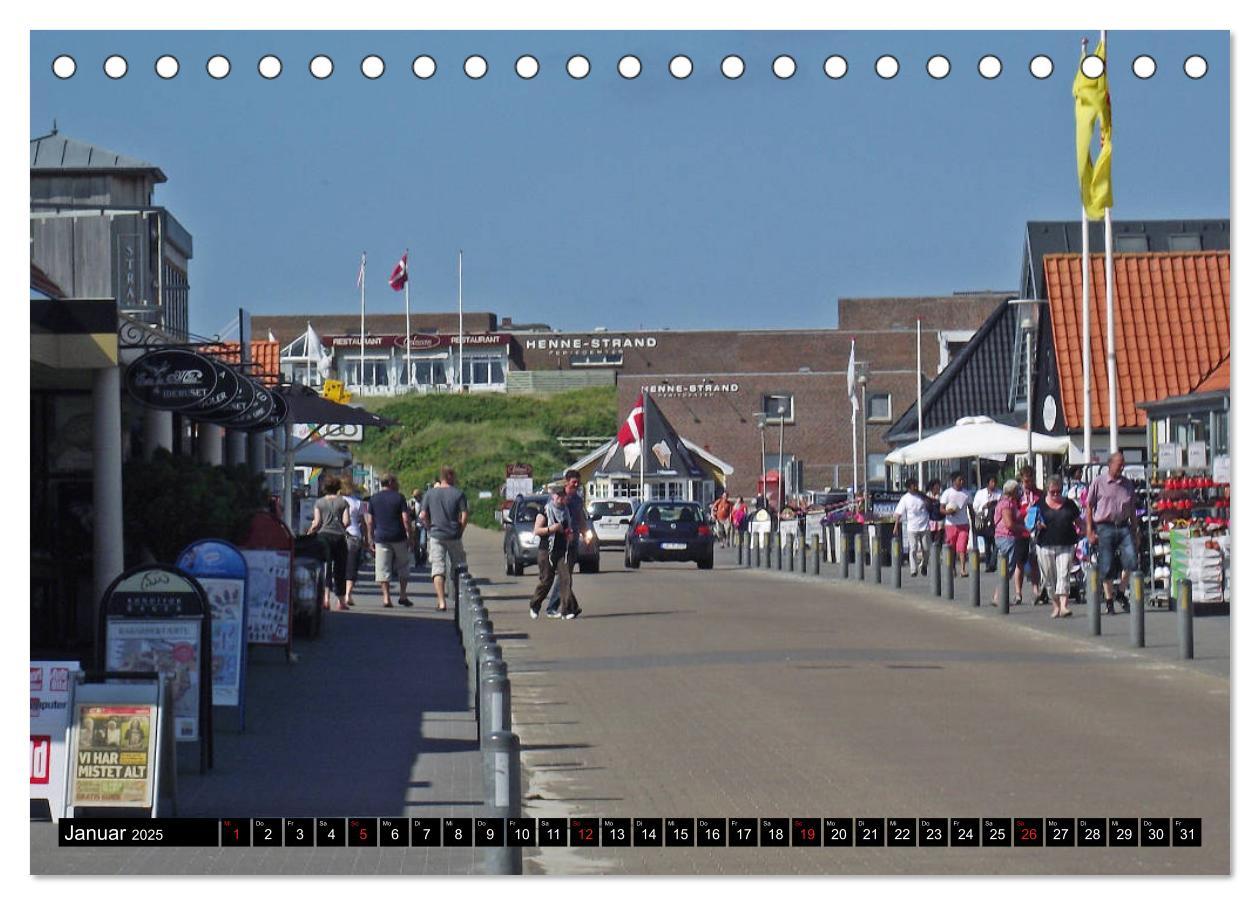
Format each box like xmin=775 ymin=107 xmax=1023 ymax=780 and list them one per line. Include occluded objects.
xmin=69 ymin=703 xmax=158 ymax=808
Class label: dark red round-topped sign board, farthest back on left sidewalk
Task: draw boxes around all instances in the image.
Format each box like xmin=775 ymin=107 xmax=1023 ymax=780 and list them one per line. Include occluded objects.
xmin=239 ymin=512 xmax=294 ymax=663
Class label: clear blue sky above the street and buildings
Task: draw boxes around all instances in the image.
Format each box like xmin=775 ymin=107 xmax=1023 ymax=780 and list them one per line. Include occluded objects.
xmin=30 ymin=30 xmax=1230 ymax=333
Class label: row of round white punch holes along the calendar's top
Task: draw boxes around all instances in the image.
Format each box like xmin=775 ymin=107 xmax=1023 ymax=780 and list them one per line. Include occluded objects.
xmin=53 ymin=53 xmax=1208 ymax=81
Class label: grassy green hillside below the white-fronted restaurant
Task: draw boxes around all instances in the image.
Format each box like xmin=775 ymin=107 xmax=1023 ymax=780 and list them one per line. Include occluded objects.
xmin=358 ymin=387 xmax=617 ymax=528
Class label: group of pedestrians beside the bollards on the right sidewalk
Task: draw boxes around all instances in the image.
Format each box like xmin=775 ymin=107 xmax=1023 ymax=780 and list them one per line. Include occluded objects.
xmin=893 ymin=453 xmax=1139 ymax=619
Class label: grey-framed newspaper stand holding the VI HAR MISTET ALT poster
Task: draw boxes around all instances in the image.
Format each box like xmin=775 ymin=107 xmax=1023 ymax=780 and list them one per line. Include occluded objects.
xmin=59 ymin=672 xmax=176 ymax=818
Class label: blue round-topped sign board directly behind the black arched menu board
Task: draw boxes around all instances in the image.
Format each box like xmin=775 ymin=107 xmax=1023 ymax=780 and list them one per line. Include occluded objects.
xmin=175 ymin=539 xmax=249 ymax=732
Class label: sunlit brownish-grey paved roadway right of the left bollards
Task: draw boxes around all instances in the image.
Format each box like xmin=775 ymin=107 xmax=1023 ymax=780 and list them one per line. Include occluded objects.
xmin=467 ymin=533 xmax=1231 ymax=875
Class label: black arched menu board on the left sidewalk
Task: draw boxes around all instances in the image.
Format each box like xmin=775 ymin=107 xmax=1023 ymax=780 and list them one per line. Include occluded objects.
xmin=97 ymin=566 xmax=214 ymax=773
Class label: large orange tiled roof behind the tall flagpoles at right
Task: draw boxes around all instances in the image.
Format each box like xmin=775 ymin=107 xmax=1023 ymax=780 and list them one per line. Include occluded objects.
xmin=1045 ymin=252 xmax=1230 ymax=430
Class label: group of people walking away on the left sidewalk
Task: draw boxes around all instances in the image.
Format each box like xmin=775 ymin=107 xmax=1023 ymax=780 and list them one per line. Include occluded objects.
xmin=306 ymin=466 xmax=467 ymax=610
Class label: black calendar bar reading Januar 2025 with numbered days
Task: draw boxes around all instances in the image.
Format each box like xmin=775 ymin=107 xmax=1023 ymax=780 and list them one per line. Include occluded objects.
xmin=57 ymin=817 xmax=1203 ymax=856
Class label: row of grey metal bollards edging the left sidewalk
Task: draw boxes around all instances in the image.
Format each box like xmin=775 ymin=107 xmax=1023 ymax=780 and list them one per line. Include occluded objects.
xmin=451 ymin=566 xmax=522 ymax=875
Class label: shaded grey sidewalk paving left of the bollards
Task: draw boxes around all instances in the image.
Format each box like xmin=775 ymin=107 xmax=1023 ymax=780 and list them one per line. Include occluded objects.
xmin=30 ymin=564 xmax=484 ymax=875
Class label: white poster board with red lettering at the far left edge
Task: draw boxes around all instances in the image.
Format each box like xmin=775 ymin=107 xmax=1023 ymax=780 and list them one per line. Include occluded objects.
xmin=30 ymin=660 xmax=79 ymax=823
